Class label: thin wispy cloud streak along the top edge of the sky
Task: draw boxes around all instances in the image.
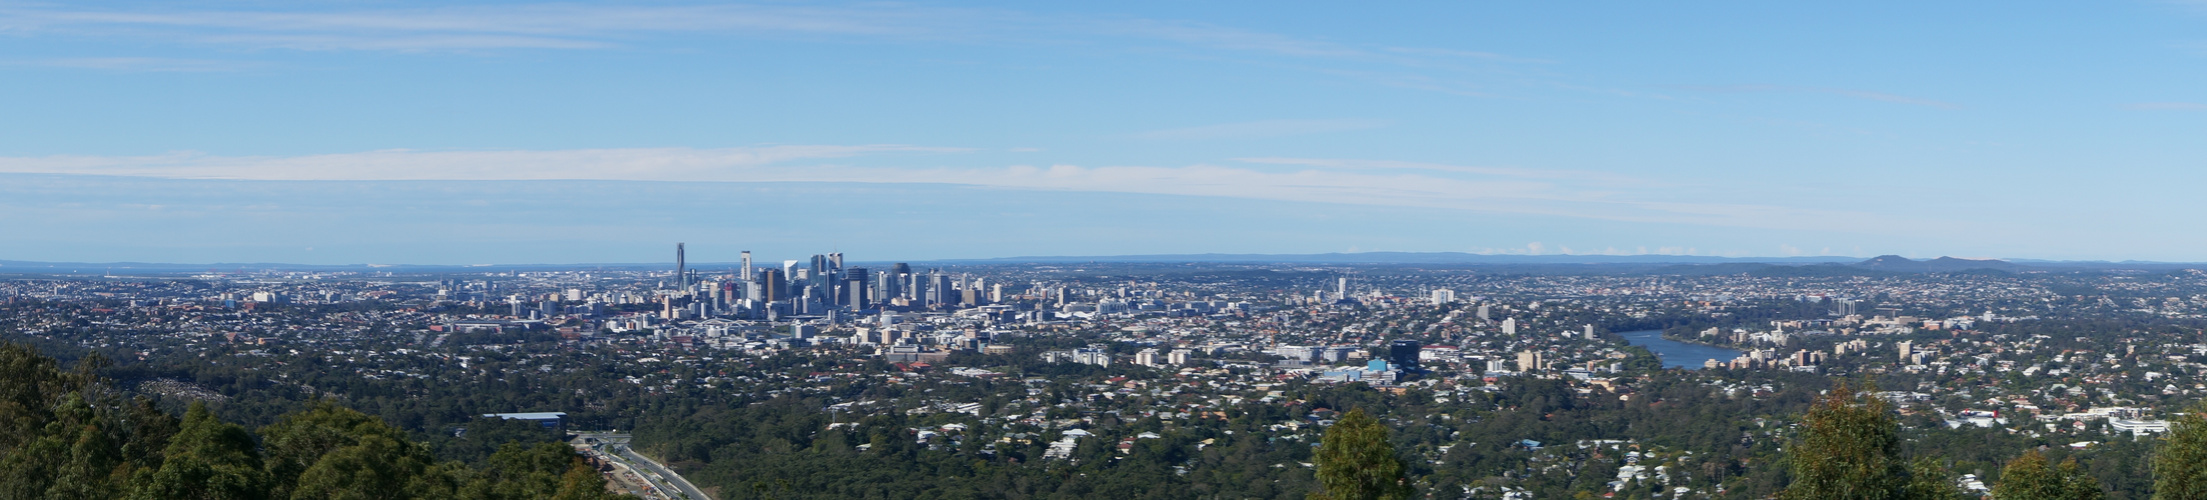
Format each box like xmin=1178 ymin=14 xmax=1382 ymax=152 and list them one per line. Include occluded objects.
xmin=0 ymin=4 xmax=1547 ymax=97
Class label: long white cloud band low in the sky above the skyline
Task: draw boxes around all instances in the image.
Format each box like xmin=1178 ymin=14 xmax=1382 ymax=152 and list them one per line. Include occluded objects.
xmin=0 ymin=145 xmax=1918 ymax=231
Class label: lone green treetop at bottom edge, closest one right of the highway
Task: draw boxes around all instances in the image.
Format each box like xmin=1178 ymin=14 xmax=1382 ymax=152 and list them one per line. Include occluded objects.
xmin=1311 ymin=407 xmax=1410 ymax=500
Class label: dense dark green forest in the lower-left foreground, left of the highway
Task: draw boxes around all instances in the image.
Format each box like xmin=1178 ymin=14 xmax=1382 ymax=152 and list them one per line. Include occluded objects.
xmin=0 ymin=344 xmax=631 ymax=500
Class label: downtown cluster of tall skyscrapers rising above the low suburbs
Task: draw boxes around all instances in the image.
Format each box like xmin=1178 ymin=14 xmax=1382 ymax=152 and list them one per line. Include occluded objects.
xmin=662 ymin=242 xmax=1004 ymax=319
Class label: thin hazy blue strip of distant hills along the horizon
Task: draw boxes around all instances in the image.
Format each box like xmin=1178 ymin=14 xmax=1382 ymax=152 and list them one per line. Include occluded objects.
xmin=0 ymin=251 xmax=2207 ymax=275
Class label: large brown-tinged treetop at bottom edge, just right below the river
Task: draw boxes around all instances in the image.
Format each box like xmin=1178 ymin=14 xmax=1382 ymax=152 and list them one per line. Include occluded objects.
xmin=1781 ymin=381 xmax=1909 ymax=500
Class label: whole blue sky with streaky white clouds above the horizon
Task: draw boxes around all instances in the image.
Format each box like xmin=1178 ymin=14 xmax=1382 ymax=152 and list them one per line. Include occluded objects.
xmin=0 ymin=2 xmax=2207 ymax=264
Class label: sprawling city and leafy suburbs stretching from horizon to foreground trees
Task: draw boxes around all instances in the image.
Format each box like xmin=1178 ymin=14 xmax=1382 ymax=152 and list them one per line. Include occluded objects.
xmin=0 ymin=251 xmax=2207 ymax=498
